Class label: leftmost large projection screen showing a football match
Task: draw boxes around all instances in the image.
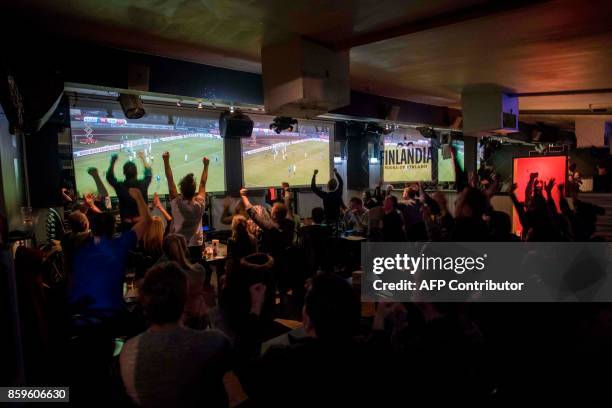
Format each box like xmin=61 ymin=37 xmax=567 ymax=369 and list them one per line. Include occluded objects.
xmin=70 ymin=104 xmax=225 ymax=196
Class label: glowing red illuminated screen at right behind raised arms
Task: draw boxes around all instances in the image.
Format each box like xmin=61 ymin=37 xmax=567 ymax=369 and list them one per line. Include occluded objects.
xmin=512 ymin=156 xmax=567 ymax=233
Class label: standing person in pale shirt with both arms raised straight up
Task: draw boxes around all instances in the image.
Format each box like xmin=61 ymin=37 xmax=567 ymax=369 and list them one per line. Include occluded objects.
xmin=162 ymin=152 xmax=210 ymax=260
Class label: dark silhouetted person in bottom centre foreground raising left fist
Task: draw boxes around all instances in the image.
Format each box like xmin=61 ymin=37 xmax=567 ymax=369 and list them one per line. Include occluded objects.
xmin=236 ymin=274 xmax=371 ymax=407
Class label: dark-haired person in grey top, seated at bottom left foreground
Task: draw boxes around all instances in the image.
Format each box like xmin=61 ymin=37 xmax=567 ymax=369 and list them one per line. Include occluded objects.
xmin=120 ymin=262 xmax=230 ymax=407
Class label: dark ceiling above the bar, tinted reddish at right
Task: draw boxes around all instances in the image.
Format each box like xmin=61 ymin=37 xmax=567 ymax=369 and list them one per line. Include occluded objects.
xmin=0 ymin=0 xmax=612 ymax=118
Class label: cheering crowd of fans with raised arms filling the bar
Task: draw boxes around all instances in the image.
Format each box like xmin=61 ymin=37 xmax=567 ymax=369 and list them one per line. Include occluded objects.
xmin=11 ymin=147 xmax=612 ymax=407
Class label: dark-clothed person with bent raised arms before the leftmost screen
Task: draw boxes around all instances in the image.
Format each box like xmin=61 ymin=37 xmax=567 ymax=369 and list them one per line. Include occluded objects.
xmin=106 ymin=151 xmax=153 ymax=231
